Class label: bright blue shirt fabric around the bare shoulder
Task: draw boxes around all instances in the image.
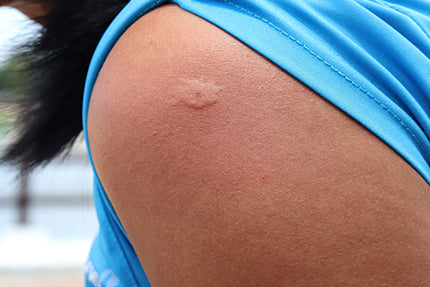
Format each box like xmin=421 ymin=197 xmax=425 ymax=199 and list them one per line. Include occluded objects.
xmin=83 ymin=0 xmax=430 ymax=286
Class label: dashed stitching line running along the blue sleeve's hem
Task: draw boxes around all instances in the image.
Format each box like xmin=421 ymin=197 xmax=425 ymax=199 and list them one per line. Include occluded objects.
xmin=221 ymin=0 xmax=428 ymax=157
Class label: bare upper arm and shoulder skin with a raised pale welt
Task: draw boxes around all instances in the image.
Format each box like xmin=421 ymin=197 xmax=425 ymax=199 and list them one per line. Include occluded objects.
xmin=89 ymin=5 xmax=430 ymax=287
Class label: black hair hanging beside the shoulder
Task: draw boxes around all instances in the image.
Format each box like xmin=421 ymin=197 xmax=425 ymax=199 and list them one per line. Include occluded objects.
xmin=2 ymin=0 xmax=127 ymax=173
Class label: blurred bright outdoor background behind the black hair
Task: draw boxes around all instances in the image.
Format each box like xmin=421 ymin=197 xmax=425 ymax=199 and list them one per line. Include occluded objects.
xmin=0 ymin=7 xmax=98 ymax=287
